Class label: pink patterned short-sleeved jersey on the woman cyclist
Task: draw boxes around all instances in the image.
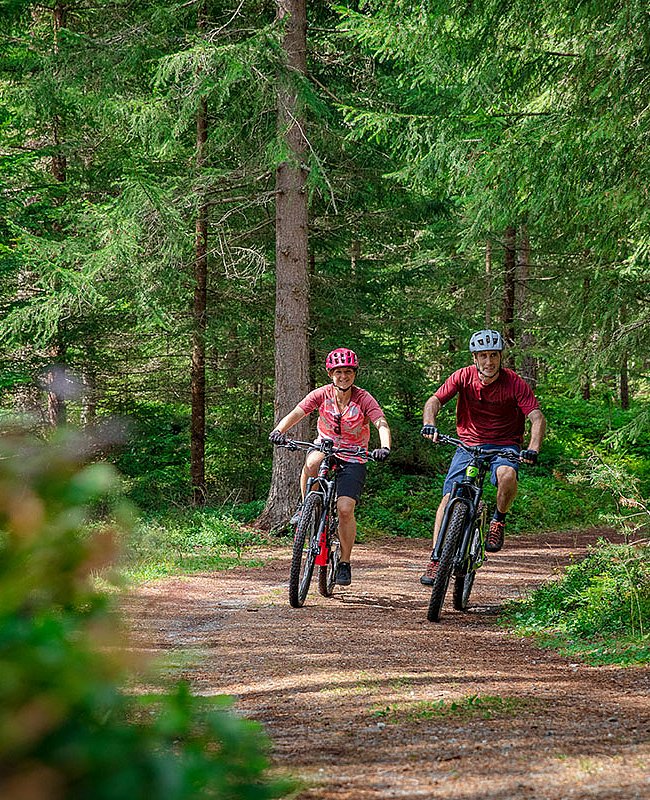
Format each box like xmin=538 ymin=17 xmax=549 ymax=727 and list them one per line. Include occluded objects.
xmin=298 ymin=383 xmax=384 ymax=463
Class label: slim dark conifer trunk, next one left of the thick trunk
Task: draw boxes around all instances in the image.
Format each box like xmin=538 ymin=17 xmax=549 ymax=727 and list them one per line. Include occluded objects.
xmin=190 ymin=3 xmax=208 ymax=506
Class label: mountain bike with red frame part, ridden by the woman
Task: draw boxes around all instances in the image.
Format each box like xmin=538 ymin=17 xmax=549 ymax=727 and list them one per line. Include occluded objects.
xmin=280 ymin=439 xmax=374 ymax=608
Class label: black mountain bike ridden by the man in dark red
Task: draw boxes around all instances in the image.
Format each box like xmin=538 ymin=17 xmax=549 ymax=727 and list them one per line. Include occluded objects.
xmin=420 ymin=433 xmax=521 ymax=622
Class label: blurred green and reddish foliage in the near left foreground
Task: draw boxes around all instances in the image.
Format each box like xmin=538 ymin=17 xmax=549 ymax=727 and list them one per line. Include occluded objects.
xmin=0 ymin=432 xmax=290 ymax=800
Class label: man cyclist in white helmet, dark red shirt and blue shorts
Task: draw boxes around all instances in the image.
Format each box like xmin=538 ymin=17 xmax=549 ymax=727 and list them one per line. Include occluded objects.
xmin=420 ymin=330 xmax=546 ymax=586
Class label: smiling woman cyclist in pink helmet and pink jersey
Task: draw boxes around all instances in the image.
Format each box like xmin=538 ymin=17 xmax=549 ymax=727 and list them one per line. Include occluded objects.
xmin=269 ymin=347 xmax=391 ymax=586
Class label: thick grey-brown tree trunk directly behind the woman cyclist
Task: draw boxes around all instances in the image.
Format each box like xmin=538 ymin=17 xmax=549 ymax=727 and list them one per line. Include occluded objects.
xmin=257 ymin=0 xmax=309 ymax=530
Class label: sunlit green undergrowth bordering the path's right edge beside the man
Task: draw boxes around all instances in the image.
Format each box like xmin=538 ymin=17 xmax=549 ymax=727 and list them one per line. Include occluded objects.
xmin=502 ymin=539 xmax=650 ymax=665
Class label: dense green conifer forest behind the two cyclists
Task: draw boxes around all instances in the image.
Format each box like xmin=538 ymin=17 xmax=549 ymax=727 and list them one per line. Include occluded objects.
xmin=0 ymin=0 xmax=650 ymax=529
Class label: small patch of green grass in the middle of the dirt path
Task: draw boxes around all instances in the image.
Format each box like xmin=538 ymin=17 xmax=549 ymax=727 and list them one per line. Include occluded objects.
xmin=371 ymin=694 xmax=526 ymax=724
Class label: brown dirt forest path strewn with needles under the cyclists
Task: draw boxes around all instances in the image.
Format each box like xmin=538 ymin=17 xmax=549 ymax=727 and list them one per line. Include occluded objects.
xmin=125 ymin=532 xmax=650 ymax=800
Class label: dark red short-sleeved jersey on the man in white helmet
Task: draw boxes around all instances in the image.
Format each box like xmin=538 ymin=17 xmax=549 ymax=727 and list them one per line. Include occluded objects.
xmin=435 ymin=365 xmax=539 ymax=446
